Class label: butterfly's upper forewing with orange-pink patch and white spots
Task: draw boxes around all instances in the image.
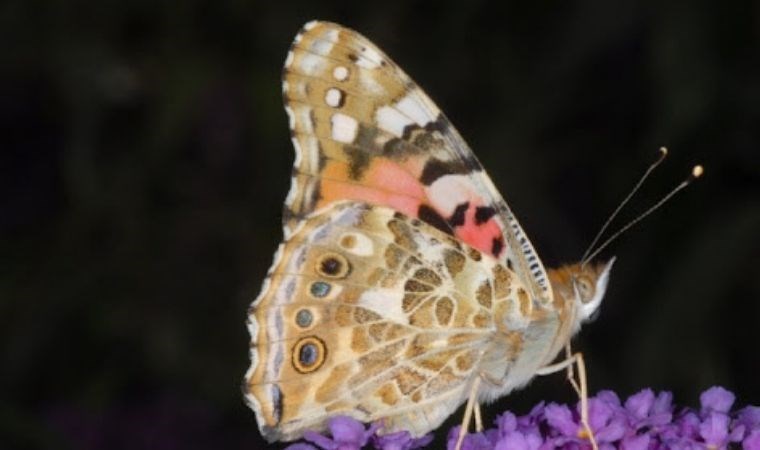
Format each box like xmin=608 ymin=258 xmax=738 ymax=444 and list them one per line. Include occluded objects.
xmin=283 ymin=22 xmax=551 ymax=302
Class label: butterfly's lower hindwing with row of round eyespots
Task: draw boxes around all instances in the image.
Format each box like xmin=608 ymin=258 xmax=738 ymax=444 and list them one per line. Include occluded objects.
xmin=245 ymin=202 xmax=530 ymax=440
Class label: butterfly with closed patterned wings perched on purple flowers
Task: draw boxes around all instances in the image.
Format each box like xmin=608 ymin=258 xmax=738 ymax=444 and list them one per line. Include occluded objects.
xmin=243 ymin=21 xmax=612 ymax=441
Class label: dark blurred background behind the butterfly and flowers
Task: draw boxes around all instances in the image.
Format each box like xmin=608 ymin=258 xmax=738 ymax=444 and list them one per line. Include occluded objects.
xmin=0 ymin=0 xmax=760 ymax=449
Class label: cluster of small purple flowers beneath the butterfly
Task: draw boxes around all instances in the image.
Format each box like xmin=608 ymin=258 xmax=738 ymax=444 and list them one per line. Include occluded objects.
xmin=286 ymin=387 xmax=760 ymax=450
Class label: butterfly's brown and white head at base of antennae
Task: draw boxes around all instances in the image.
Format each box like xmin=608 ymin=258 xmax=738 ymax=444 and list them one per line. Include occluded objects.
xmin=549 ymin=258 xmax=615 ymax=326
